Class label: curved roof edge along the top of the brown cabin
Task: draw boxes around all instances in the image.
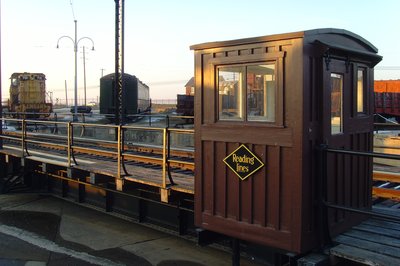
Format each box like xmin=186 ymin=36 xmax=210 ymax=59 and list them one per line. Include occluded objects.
xmin=190 ymin=28 xmax=378 ymax=53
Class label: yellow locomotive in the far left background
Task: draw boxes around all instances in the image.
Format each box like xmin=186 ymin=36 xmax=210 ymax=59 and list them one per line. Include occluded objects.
xmin=9 ymin=72 xmax=53 ymax=117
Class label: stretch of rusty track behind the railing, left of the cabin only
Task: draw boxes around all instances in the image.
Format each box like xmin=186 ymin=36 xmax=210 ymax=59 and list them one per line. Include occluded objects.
xmin=3 ymin=128 xmax=194 ymax=171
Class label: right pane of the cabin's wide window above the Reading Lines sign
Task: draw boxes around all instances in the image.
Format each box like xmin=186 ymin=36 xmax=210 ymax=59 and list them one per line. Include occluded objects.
xmin=247 ymin=64 xmax=275 ymax=122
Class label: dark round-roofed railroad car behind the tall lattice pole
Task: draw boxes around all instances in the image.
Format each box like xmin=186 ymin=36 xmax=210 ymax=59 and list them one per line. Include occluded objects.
xmin=100 ymin=73 xmax=151 ymax=115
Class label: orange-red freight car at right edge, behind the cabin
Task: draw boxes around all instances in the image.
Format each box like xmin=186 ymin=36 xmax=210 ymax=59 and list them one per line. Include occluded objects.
xmin=374 ymin=80 xmax=400 ymax=122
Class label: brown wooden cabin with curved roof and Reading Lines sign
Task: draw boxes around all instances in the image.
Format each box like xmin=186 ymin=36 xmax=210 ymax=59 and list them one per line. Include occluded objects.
xmin=191 ymin=29 xmax=381 ymax=253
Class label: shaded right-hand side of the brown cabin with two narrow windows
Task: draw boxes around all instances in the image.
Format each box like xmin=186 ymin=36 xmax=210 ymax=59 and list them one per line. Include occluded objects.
xmin=322 ymin=57 xmax=373 ymax=235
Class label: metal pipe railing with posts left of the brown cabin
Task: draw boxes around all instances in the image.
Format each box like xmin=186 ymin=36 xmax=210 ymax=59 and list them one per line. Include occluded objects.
xmin=0 ymin=118 xmax=194 ymax=192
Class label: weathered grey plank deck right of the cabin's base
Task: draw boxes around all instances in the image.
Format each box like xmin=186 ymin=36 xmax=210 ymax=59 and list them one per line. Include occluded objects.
xmin=330 ymin=210 xmax=400 ymax=266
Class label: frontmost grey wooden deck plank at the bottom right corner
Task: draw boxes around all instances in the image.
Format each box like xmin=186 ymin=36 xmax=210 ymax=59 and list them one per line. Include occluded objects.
xmin=330 ymin=244 xmax=400 ymax=266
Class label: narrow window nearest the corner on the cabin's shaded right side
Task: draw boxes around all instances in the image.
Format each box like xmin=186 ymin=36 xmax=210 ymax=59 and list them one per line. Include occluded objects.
xmin=331 ymin=73 xmax=343 ymax=135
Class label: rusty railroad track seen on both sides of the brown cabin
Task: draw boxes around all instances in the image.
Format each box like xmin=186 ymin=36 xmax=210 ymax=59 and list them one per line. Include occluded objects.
xmin=3 ymin=122 xmax=400 ymax=202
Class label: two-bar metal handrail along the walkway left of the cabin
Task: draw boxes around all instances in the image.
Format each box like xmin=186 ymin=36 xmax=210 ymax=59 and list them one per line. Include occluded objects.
xmin=0 ymin=116 xmax=194 ymax=192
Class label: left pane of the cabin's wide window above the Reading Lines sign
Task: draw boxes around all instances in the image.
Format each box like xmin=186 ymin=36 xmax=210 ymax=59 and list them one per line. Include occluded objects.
xmin=218 ymin=66 xmax=245 ymax=120
